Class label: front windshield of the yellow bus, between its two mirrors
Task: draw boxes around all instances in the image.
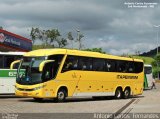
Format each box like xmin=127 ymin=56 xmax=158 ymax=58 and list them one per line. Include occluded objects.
xmin=16 ymin=57 xmax=45 ymax=85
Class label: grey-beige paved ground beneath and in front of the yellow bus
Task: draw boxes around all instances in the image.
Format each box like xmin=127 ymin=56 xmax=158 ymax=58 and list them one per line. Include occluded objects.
xmin=0 ymin=84 xmax=160 ymax=119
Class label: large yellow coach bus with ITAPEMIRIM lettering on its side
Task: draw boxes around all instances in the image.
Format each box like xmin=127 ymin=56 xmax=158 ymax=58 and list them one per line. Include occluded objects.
xmin=15 ymin=49 xmax=144 ymax=102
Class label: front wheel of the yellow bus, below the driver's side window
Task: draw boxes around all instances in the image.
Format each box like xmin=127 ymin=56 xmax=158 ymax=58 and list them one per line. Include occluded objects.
xmin=56 ymin=89 xmax=67 ymax=102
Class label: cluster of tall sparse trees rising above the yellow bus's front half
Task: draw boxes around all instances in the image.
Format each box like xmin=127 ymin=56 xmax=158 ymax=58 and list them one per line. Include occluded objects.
xmin=30 ymin=27 xmax=84 ymax=50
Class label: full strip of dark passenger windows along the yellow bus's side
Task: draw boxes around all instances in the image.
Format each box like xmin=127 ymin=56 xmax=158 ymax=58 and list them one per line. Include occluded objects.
xmin=62 ymin=56 xmax=143 ymax=73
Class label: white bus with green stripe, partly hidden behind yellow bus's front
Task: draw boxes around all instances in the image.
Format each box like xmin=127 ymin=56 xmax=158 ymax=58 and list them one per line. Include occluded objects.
xmin=0 ymin=52 xmax=24 ymax=94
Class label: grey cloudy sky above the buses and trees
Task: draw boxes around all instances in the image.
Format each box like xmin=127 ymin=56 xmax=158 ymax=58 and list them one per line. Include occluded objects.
xmin=0 ymin=0 xmax=160 ymax=55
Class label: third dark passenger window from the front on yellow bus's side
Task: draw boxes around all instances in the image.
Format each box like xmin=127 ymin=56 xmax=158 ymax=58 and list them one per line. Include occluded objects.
xmin=93 ymin=58 xmax=105 ymax=71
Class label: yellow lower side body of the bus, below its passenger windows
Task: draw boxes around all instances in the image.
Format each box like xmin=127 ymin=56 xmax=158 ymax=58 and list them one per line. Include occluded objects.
xmin=57 ymin=71 xmax=143 ymax=96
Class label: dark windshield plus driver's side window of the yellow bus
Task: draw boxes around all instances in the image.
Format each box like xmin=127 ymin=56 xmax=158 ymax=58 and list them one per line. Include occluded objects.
xmin=16 ymin=54 xmax=64 ymax=85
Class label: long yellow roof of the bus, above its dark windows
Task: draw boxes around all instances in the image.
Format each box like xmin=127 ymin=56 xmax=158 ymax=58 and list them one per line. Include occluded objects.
xmin=24 ymin=48 xmax=143 ymax=62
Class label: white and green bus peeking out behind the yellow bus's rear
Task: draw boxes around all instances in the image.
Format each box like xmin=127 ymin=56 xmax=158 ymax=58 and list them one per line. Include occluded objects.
xmin=144 ymin=64 xmax=154 ymax=89
